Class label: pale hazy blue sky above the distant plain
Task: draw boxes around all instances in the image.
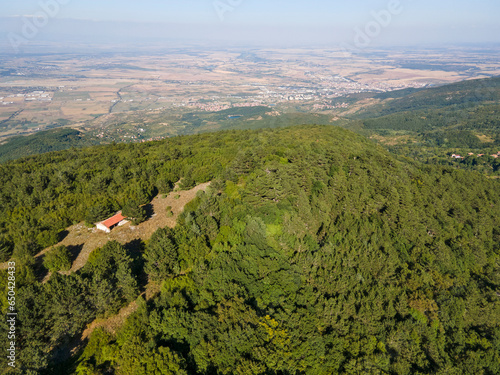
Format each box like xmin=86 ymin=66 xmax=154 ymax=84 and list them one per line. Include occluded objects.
xmin=0 ymin=0 xmax=500 ymax=50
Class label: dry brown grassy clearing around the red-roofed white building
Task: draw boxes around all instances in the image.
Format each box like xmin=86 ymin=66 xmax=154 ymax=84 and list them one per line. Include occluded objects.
xmin=0 ymin=182 xmax=210 ymax=274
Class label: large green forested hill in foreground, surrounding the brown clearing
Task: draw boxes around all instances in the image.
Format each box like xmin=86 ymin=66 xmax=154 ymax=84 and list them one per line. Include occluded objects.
xmin=0 ymin=126 xmax=500 ymax=375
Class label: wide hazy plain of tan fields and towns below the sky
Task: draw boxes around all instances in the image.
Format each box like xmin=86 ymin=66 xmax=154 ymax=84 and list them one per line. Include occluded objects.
xmin=0 ymin=48 xmax=500 ymax=142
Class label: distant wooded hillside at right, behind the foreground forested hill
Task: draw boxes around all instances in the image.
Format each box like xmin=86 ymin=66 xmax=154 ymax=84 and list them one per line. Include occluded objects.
xmin=347 ymin=77 xmax=500 ymax=176
